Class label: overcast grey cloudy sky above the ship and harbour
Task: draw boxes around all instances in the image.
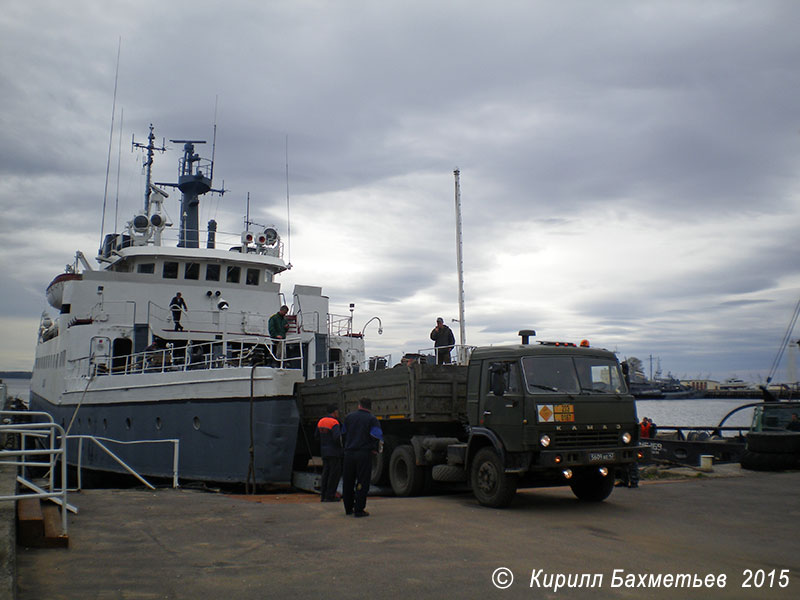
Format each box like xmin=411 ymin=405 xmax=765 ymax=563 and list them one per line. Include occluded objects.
xmin=0 ymin=0 xmax=800 ymax=381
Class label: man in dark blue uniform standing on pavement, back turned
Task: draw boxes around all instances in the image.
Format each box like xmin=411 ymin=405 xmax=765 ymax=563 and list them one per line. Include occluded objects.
xmin=342 ymin=398 xmax=383 ymax=517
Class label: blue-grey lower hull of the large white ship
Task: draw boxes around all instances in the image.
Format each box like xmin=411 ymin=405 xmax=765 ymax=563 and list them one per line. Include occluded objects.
xmin=30 ymin=380 xmax=300 ymax=484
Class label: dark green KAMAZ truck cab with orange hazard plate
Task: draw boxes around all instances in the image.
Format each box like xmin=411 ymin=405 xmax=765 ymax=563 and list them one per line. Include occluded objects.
xmin=464 ymin=337 xmax=642 ymax=506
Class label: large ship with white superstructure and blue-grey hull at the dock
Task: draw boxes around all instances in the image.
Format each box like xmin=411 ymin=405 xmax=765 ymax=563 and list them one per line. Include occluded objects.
xmin=31 ymin=128 xmax=364 ymax=482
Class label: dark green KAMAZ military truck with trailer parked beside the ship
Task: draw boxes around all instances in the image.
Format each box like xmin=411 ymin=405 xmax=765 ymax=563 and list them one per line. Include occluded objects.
xmin=298 ymin=331 xmax=644 ymax=507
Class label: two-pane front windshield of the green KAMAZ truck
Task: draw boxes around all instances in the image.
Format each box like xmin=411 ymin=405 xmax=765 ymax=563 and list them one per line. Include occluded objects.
xmin=522 ymin=356 xmax=627 ymax=394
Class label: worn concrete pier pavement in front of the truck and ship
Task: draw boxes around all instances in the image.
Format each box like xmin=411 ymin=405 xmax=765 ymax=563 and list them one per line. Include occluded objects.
xmin=7 ymin=465 xmax=800 ymax=600
